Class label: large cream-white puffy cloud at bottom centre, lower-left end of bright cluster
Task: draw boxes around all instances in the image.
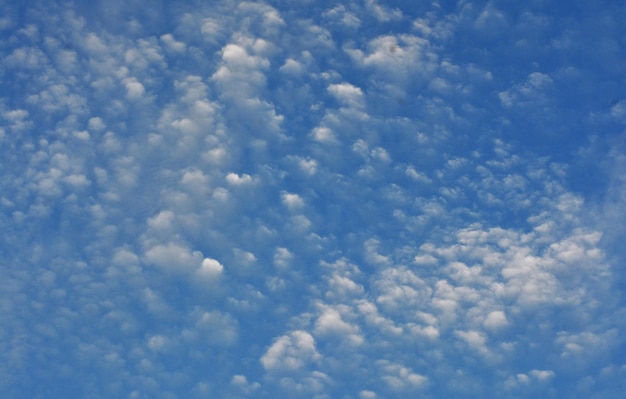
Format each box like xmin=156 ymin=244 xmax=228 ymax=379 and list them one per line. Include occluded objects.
xmin=261 ymin=330 xmax=321 ymax=371
